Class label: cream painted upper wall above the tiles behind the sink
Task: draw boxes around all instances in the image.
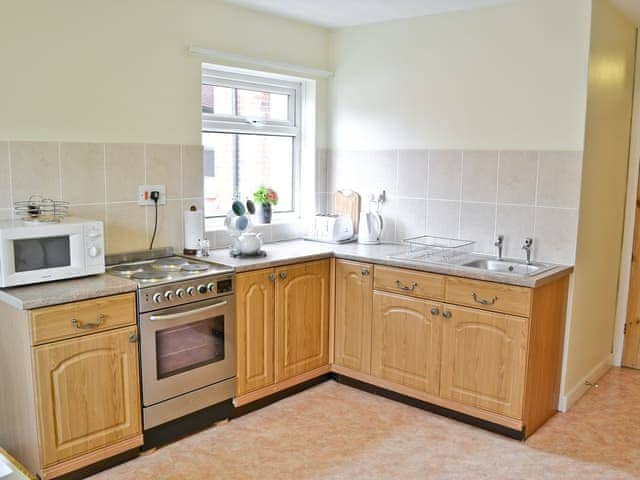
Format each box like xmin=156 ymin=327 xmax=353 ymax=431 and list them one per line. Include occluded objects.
xmin=331 ymin=0 xmax=590 ymax=150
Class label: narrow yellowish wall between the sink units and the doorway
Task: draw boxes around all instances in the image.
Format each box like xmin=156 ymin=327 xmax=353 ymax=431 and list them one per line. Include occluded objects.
xmin=565 ymin=0 xmax=636 ymax=398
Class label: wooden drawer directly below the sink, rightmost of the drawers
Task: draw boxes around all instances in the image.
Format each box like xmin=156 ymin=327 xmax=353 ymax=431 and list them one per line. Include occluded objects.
xmin=446 ymin=277 xmax=531 ymax=317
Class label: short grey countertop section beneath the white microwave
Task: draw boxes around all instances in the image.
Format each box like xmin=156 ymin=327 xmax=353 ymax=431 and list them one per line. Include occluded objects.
xmin=0 ymin=273 xmax=136 ymax=310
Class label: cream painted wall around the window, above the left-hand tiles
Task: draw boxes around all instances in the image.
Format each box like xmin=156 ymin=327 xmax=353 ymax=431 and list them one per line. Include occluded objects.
xmin=0 ymin=0 xmax=329 ymax=146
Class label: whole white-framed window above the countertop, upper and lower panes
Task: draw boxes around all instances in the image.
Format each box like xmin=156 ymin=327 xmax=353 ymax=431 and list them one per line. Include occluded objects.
xmin=201 ymin=66 xmax=302 ymax=218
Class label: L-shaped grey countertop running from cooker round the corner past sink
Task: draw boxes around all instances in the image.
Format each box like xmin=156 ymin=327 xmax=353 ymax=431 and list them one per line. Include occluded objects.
xmin=199 ymin=240 xmax=573 ymax=288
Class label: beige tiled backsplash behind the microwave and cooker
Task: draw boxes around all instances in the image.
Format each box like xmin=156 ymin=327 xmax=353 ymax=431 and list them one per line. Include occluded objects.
xmin=0 ymin=141 xmax=203 ymax=253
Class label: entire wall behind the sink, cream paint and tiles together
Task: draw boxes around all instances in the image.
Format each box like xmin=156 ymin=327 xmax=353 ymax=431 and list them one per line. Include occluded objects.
xmin=325 ymin=0 xmax=590 ymax=264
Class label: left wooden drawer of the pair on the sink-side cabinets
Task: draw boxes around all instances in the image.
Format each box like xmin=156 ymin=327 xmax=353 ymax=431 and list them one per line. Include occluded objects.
xmin=373 ymin=266 xmax=445 ymax=300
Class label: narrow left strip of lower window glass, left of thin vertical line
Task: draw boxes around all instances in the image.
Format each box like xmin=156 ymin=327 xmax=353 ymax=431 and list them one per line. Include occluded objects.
xmin=202 ymin=133 xmax=235 ymax=217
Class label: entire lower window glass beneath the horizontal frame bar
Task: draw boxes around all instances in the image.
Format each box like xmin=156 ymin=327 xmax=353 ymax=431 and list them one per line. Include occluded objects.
xmin=202 ymin=129 xmax=294 ymax=217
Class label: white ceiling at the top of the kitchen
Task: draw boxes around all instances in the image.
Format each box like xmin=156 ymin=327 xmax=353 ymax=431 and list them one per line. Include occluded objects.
xmin=226 ymin=0 xmax=516 ymax=28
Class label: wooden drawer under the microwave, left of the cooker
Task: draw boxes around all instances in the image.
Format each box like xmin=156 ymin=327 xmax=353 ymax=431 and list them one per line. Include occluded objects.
xmin=30 ymin=293 xmax=136 ymax=345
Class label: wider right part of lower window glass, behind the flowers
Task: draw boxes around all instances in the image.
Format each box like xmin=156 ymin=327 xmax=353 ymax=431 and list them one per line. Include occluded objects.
xmin=238 ymin=135 xmax=293 ymax=212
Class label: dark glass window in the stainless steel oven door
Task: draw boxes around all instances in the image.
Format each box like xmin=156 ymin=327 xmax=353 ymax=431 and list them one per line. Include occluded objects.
xmin=156 ymin=315 xmax=224 ymax=379
